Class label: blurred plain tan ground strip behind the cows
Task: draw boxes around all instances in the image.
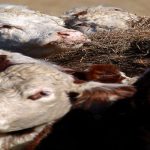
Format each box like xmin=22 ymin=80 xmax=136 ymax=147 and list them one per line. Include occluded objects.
xmin=0 ymin=0 xmax=150 ymax=16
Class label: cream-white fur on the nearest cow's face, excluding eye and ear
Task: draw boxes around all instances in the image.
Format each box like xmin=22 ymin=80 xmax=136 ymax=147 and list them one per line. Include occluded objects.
xmin=0 ymin=50 xmax=73 ymax=149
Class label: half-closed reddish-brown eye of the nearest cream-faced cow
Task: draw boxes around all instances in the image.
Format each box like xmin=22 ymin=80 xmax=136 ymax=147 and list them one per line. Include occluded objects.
xmin=28 ymin=91 xmax=49 ymax=100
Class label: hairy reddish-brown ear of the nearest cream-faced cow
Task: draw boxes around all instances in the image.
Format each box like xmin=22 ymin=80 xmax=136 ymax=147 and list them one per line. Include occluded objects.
xmin=69 ymin=86 xmax=136 ymax=109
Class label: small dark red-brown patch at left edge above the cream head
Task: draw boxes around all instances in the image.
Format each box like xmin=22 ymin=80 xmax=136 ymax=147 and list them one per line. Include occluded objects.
xmin=0 ymin=55 xmax=12 ymax=72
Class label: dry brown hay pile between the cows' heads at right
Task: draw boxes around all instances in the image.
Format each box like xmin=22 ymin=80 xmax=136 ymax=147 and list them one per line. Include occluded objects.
xmin=48 ymin=28 xmax=150 ymax=76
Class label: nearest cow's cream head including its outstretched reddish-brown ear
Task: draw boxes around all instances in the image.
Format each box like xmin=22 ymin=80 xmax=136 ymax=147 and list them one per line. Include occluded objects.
xmin=0 ymin=50 xmax=136 ymax=150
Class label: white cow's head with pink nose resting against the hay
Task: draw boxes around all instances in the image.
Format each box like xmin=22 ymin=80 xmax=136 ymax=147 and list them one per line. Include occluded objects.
xmin=0 ymin=5 xmax=90 ymax=58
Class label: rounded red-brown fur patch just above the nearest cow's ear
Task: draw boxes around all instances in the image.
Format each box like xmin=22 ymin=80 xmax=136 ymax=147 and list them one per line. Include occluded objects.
xmin=73 ymin=64 xmax=125 ymax=83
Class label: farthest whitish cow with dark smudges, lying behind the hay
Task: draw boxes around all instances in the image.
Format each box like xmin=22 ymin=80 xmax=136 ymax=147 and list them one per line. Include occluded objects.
xmin=62 ymin=5 xmax=140 ymax=35
